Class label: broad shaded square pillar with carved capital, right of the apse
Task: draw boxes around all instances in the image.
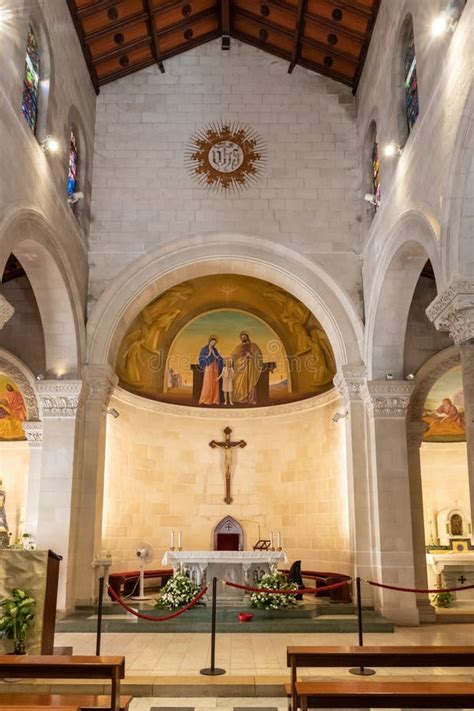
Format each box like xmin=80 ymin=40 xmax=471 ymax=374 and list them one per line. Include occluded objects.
xmin=363 ymin=380 xmax=419 ymax=625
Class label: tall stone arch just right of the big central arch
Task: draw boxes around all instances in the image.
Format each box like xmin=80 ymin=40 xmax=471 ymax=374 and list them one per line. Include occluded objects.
xmin=365 ymin=210 xmax=440 ymax=379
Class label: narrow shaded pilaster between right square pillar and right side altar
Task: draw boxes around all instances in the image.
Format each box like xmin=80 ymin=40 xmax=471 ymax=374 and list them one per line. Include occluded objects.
xmin=407 ymin=421 xmax=436 ymax=622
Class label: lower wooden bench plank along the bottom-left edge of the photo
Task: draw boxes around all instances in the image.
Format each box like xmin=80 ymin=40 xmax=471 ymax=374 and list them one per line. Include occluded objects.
xmin=0 ymin=692 xmax=133 ymax=711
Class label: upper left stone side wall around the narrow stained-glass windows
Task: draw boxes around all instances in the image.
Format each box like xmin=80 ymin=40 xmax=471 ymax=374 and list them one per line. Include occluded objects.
xmin=0 ymin=0 xmax=96 ymax=308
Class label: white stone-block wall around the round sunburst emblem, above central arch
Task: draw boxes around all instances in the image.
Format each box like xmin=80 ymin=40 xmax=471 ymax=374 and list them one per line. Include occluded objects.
xmin=89 ymin=39 xmax=361 ymax=316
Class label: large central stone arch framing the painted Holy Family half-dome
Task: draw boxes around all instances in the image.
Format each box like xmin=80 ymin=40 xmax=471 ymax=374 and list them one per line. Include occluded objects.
xmin=88 ymin=234 xmax=362 ymax=376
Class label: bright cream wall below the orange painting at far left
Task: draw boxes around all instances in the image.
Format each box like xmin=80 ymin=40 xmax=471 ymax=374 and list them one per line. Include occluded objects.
xmin=0 ymin=441 xmax=30 ymax=542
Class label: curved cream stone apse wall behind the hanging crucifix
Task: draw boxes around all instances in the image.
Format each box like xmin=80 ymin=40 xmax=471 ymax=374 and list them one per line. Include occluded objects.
xmin=102 ymin=390 xmax=351 ymax=572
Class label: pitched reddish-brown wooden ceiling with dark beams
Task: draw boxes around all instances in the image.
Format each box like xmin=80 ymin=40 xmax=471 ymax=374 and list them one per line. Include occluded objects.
xmin=67 ymin=0 xmax=380 ymax=92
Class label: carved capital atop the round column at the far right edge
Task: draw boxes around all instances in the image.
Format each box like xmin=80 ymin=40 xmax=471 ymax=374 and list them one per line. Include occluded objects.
xmin=426 ymin=278 xmax=474 ymax=346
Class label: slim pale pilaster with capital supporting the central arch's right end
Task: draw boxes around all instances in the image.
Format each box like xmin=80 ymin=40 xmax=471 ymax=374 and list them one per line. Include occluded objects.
xmin=334 ymin=363 xmax=374 ymax=604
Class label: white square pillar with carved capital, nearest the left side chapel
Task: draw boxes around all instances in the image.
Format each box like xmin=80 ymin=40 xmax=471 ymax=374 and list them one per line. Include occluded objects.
xmin=36 ymin=380 xmax=82 ymax=610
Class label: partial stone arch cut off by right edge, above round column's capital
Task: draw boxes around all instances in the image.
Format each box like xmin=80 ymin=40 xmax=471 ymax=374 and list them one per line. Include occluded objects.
xmin=443 ymin=86 xmax=474 ymax=283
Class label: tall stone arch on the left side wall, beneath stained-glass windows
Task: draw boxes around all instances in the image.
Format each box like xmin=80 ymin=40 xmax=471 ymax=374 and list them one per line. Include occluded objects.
xmin=0 ymin=209 xmax=85 ymax=377
